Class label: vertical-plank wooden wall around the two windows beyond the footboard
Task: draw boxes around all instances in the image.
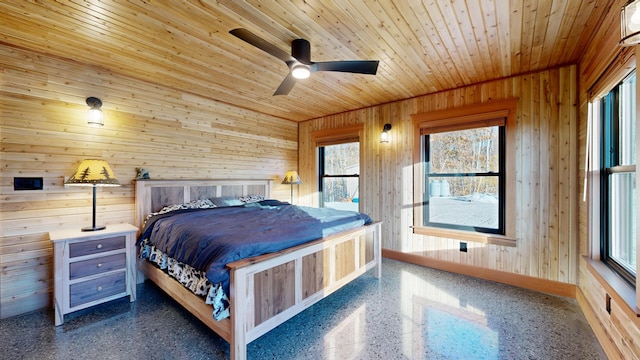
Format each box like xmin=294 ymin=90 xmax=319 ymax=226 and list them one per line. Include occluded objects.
xmin=300 ymin=65 xmax=579 ymax=284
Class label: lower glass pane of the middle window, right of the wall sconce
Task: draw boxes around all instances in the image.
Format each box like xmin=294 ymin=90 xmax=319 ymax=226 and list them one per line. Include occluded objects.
xmin=427 ymin=176 xmax=499 ymax=229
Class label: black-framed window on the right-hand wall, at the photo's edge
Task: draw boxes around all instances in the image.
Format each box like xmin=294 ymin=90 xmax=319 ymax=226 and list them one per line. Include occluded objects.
xmin=596 ymin=72 xmax=636 ymax=286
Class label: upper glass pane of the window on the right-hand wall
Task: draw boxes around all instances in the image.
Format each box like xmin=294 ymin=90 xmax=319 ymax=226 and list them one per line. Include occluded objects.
xmin=618 ymin=74 xmax=636 ymax=165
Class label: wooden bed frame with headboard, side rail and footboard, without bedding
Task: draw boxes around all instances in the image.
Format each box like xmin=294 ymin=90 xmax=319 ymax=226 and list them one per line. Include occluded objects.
xmin=135 ymin=179 xmax=382 ymax=359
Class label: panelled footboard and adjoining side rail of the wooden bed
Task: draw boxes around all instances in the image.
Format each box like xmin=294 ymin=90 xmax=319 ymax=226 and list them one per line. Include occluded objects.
xmin=139 ymin=222 xmax=382 ymax=359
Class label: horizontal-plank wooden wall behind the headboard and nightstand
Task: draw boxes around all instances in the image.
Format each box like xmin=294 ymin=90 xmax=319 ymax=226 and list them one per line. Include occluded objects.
xmin=0 ymin=45 xmax=298 ymax=318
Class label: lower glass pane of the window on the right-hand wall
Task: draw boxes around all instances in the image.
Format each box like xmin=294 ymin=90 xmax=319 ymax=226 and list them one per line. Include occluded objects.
xmin=609 ymin=172 xmax=636 ymax=275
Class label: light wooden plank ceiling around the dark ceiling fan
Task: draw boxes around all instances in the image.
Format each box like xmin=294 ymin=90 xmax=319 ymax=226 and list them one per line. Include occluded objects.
xmin=0 ymin=0 xmax=612 ymax=121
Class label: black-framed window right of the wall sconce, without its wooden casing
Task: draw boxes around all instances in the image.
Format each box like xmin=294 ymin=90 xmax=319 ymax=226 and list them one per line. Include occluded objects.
xmin=423 ymin=125 xmax=505 ymax=235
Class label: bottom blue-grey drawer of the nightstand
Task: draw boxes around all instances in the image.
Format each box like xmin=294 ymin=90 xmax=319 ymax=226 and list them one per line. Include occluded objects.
xmin=69 ymin=271 xmax=126 ymax=307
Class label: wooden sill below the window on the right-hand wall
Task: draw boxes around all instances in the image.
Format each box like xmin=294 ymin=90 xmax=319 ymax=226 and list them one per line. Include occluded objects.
xmin=583 ymin=256 xmax=640 ymax=317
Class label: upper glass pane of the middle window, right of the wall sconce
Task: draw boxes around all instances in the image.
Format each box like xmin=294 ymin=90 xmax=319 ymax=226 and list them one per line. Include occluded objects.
xmin=429 ymin=126 xmax=499 ymax=174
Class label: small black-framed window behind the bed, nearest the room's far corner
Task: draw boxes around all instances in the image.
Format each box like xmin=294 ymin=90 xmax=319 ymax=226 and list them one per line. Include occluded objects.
xmin=318 ymin=142 xmax=360 ymax=211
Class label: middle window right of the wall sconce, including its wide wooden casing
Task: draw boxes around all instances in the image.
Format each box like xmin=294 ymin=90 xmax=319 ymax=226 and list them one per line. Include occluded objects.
xmin=412 ymin=99 xmax=518 ymax=246
